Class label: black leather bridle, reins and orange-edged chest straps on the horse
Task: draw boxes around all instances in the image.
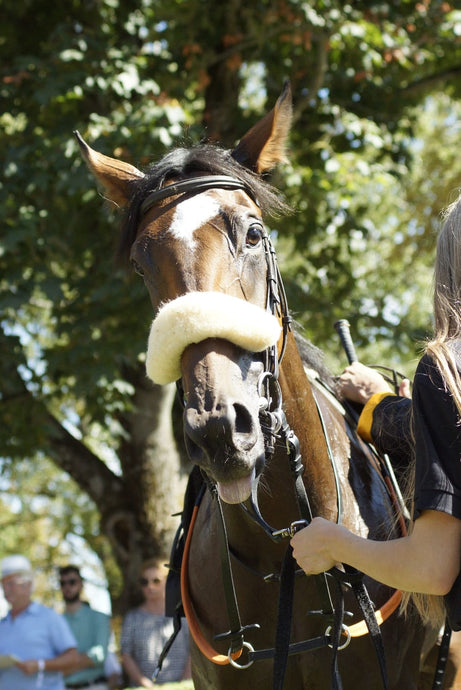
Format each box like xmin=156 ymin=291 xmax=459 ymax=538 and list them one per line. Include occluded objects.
xmin=140 ymin=175 xmax=401 ymax=690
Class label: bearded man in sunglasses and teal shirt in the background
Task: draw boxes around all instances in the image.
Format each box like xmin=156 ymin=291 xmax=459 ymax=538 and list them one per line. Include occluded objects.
xmin=59 ymin=565 xmax=111 ymax=690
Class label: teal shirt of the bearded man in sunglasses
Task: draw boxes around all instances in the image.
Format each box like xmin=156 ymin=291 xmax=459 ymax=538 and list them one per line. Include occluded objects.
xmin=63 ymin=604 xmax=110 ymax=685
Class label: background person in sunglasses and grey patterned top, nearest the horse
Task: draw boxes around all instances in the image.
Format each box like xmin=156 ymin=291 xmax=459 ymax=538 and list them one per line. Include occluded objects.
xmin=121 ymin=559 xmax=190 ymax=688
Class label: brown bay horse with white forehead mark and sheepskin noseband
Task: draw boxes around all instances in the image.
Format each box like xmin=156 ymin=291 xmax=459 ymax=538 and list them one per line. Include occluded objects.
xmin=76 ymin=84 xmax=424 ymax=690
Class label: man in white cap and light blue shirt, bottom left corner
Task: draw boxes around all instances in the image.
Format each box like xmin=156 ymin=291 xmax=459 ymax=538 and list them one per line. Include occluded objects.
xmin=0 ymin=554 xmax=78 ymax=690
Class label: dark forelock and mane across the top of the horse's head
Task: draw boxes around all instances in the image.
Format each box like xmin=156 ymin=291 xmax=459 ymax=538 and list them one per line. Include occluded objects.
xmin=117 ymin=144 xmax=290 ymax=263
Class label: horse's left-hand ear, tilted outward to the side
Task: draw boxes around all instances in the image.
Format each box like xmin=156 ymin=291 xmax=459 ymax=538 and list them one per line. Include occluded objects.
xmin=74 ymin=131 xmax=144 ymax=208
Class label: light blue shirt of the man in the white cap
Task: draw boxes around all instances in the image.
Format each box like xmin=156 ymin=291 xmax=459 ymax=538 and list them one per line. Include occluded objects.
xmin=0 ymin=602 xmax=77 ymax=690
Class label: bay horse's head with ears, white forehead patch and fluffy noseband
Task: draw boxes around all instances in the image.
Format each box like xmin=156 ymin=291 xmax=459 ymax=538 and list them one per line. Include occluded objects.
xmin=77 ymin=84 xmax=292 ymax=503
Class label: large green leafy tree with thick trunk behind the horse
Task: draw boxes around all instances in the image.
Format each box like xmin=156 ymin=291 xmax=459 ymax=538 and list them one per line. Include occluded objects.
xmin=0 ymin=0 xmax=461 ymax=610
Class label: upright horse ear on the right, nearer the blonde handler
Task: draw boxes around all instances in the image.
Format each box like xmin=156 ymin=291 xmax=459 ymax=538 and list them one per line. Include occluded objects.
xmin=232 ymin=81 xmax=293 ymax=173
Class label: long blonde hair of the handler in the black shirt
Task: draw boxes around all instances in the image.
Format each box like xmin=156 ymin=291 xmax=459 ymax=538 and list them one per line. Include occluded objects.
xmin=402 ymin=195 xmax=461 ymax=625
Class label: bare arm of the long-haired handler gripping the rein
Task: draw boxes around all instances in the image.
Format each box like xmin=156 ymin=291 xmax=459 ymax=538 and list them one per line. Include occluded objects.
xmin=291 ymin=510 xmax=461 ymax=595
